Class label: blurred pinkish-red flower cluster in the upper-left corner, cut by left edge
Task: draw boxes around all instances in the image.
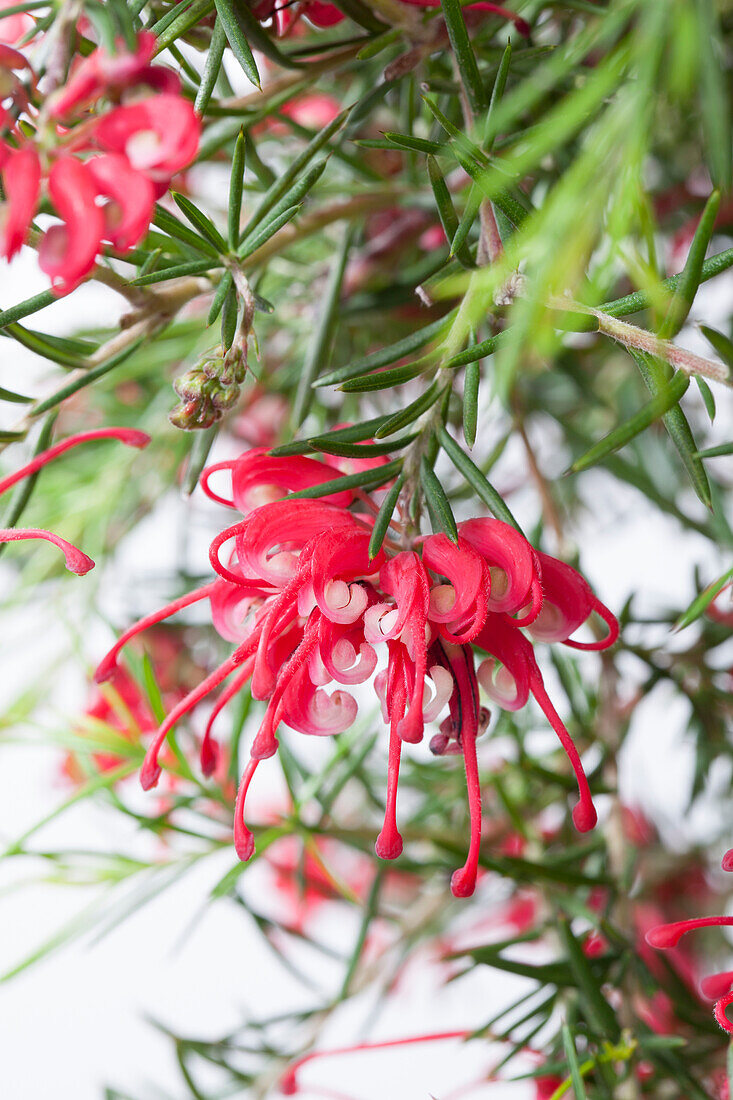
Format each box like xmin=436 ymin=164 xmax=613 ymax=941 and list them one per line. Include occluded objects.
xmin=0 ymin=31 xmax=200 ymax=295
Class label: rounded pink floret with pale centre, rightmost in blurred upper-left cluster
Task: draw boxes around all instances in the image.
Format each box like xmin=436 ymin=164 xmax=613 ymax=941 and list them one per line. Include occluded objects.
xmin=95 ymin=92 xmax=201 ymax=189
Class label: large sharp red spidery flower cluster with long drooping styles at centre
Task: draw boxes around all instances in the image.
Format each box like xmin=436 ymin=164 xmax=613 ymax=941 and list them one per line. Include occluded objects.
xmin=97 ymin=449 xmax=619 ymax=897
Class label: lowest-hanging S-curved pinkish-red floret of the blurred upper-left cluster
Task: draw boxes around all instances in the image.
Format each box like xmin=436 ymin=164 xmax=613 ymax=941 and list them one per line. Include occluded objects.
xmin=39 ymin=156 xmax=105 ymax=295
